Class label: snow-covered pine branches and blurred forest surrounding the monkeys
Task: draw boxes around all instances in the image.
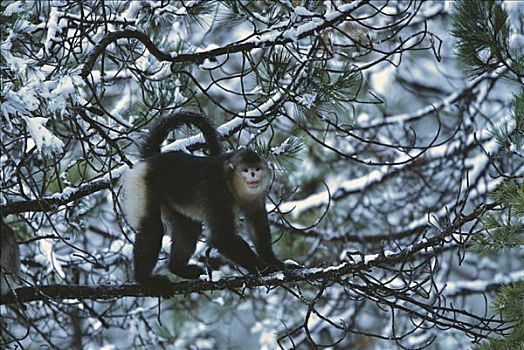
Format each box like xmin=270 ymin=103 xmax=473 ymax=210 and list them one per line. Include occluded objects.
xmin=0 ymin=0 xmax=524 ymax=350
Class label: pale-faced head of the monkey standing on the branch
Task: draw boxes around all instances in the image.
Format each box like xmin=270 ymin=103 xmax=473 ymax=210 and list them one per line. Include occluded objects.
xmin=228 ymin=150 xmax=271 ymax=202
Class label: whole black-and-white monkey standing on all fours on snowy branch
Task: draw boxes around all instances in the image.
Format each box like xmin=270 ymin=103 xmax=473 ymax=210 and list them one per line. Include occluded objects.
xmin=122 ymin=112 xmax=284 ymax=285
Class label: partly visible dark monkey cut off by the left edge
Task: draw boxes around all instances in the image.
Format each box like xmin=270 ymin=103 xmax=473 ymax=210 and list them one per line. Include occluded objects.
xmin=0 ymin=215 xmax=20 ymax=295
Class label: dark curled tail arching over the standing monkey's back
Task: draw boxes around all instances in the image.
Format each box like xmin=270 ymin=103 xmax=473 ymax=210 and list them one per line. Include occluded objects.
xmin=140 ymin=112 xmax=222 ymax=158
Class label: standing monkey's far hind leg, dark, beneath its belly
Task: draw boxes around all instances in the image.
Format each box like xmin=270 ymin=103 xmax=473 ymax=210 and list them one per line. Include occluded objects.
xmin=162 ymin=207 xmax=205 ymax=279
